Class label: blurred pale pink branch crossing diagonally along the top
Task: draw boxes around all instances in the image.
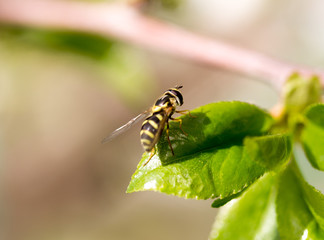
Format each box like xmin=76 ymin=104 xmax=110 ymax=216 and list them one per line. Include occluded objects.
xmin=0 ymin=0 xmax=324 ymax=89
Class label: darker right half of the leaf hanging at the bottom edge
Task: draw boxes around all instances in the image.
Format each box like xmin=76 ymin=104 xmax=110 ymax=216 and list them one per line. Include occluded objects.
xmin=276 ymin=166 xmax=313 ymax=240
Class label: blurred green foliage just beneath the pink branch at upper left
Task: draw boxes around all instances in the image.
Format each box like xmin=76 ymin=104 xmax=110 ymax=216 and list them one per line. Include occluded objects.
xmin=0 ymin=26 xmax=154 ymax=107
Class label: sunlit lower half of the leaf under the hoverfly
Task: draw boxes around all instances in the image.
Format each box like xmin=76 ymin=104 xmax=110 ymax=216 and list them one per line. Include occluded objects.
xmin=127 ymin=145 xmax=265 ymax=199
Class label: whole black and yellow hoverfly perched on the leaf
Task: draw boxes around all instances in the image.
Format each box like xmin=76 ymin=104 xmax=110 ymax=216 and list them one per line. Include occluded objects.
xmin=102 ymin=86 xmax=191 ymax=166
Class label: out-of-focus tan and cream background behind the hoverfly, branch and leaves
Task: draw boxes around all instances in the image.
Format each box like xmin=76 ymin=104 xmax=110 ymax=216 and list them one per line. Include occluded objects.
xmin=0 ymin=0 xmax=324 ymax=240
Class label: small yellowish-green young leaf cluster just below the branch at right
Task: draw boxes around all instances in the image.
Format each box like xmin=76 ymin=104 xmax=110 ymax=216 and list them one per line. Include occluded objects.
xmin=282 ymin=73 xmax=321 ymax=114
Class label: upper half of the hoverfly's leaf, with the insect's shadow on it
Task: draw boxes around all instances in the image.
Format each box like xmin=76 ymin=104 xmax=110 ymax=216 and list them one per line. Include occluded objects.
xmin=157 ymin=101 xmax=273 ymax=164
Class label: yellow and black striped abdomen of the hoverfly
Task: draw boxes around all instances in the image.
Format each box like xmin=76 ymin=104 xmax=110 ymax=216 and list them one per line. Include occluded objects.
xmin=141 ymin=111 xmax=167 ymax=152
